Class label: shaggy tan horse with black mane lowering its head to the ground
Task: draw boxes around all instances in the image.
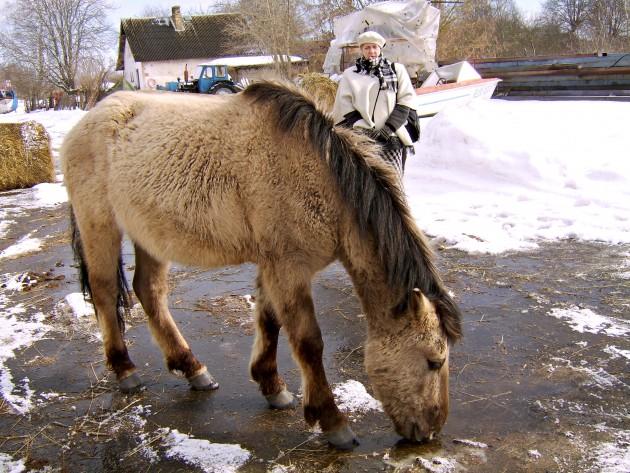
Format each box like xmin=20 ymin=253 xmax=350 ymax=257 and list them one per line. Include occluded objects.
xmin=61 ymin=82 xmax=461 ymax=449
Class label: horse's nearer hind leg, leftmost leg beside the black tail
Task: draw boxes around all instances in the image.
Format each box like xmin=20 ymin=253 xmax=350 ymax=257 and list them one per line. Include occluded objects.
xmin=73 ymin=210 xmax=142 ymax=392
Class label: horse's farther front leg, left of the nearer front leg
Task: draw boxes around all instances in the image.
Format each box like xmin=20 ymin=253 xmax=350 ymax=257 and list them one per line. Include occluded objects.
xmin=249 ymin=276 xmax=295 ymax=409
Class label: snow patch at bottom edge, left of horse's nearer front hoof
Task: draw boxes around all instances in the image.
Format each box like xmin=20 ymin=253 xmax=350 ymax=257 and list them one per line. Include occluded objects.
xmin=163 ymin=429 xmax=251 ymax=473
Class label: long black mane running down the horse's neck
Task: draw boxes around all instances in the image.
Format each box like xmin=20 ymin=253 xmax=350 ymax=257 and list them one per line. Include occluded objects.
xmin=243 ymin=82 xmax=462 ymax=341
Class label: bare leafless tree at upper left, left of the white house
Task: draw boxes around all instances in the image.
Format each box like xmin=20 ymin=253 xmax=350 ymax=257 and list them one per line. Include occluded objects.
xmin=0 ymin=0 xmax=114 ymax=93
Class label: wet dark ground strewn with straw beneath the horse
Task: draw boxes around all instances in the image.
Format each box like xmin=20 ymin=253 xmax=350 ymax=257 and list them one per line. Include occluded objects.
xmin=0 ymin=194 xmax=630 ymax=472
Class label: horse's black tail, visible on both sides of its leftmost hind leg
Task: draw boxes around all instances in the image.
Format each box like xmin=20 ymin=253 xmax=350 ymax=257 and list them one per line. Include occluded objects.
xmin=70 ymin=206 xmax=131 ymax=333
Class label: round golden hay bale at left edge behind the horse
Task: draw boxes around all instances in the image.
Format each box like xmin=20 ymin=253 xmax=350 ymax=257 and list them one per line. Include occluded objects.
xmin=0 ymin=121 xmax=55 ymax=191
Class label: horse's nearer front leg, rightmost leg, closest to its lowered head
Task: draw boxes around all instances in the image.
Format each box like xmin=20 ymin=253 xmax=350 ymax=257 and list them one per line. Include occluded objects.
xmin=263 ymin=271 xmax=359 ymax=449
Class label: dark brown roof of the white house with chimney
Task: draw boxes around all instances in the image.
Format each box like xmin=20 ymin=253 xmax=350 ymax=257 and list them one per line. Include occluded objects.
xmin=116 ymin=13 xmax=244 ymax=70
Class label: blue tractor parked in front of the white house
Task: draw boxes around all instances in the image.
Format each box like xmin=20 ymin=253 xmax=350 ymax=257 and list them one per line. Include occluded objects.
xmin=165 ymin=64 xmax=243 ymax=95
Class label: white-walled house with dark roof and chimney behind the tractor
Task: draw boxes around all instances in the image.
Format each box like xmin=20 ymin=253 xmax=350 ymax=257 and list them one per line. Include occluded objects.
xmin=116 ymin=6 xmax=246 ymax=89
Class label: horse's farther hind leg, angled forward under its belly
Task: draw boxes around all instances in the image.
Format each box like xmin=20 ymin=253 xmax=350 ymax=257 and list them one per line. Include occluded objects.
xmin=133 ymin=244 xmax=219 ymax=390
